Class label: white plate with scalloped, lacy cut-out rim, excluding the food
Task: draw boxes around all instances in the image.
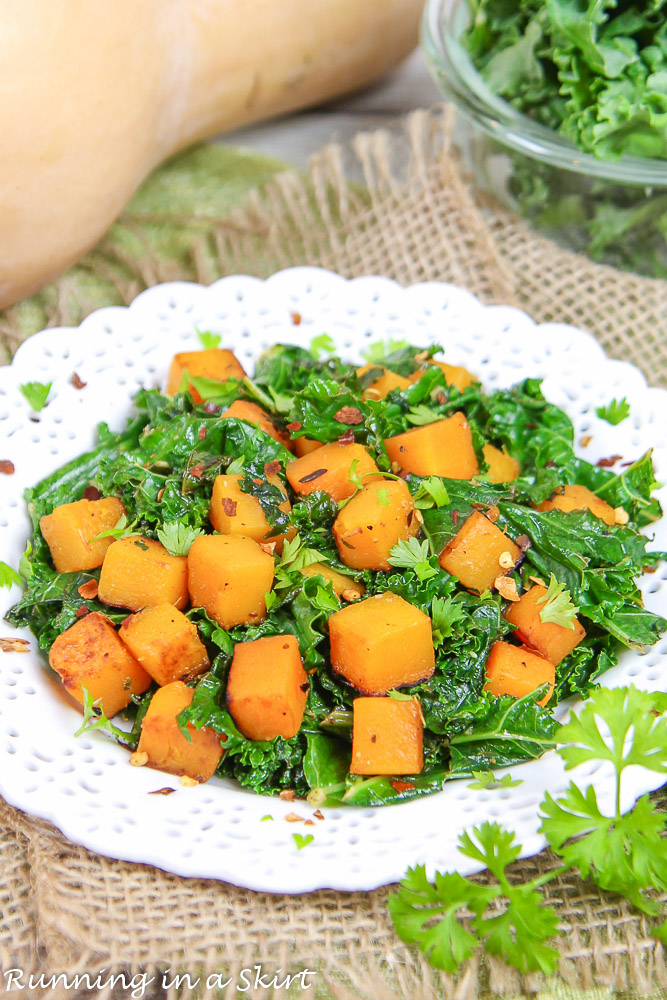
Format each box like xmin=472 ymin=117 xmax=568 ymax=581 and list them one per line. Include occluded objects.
xmin=0 ymin=268 xmax=667 ymax=892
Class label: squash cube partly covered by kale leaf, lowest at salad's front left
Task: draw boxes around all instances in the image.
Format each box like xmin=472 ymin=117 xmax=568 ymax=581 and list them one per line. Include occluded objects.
xmin=137 ymin=681 xmax=225 ymax=782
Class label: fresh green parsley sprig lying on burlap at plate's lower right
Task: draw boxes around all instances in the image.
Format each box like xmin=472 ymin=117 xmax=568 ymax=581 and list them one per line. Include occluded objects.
xmin=388 ymin=687 xmax=667 ymax=974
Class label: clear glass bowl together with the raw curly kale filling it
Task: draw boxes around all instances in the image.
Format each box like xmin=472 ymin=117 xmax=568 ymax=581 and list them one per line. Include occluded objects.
xmin=422 ymin=0 xmax=667 ymax=278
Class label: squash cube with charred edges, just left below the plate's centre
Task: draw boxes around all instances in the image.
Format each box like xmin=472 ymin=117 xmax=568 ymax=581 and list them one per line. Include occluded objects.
xmin=227 ymin=635 xmax=309 ymax=740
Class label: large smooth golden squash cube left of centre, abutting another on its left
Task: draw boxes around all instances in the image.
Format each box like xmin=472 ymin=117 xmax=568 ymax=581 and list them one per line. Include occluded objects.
xmin=188 ymin=535 xmax=274 ymax=628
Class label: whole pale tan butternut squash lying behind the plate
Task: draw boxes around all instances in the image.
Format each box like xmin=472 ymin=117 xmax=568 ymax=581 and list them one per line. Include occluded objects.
xmin=0 ymin=0 xmax=423 ymax=308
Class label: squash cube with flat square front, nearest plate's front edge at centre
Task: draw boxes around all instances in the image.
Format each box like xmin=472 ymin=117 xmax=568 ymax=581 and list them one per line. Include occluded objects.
xmin=350 ymin=698 xmax=424 ymax=774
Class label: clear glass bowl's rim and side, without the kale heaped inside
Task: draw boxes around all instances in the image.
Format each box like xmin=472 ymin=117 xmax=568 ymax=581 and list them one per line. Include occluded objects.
xmin=422 ymin=0 xmax=667 ymax=278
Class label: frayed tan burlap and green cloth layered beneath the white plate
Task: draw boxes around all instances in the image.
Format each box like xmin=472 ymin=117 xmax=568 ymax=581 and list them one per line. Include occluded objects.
xmin=0 ymin=105 xmax=667 ymax=1000
